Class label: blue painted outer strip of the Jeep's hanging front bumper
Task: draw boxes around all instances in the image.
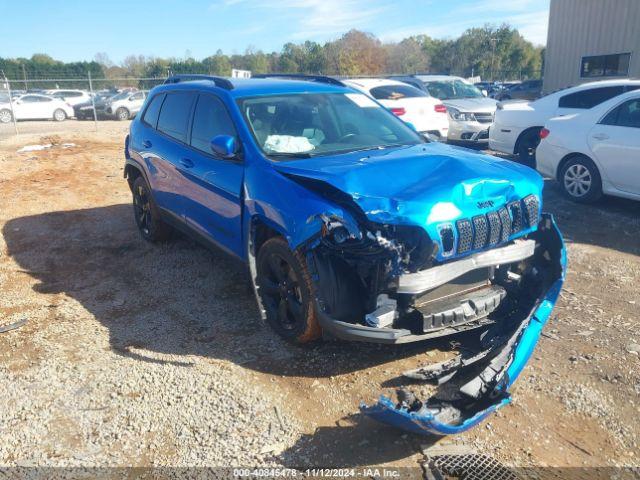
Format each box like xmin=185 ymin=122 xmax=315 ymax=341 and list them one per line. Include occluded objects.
xmin=360 ymin=215 xmax=567 ymax=435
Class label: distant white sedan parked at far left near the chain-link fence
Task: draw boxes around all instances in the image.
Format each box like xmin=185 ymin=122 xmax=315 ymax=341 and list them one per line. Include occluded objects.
xmin=0 ymin=93 xmax=73 ymax=123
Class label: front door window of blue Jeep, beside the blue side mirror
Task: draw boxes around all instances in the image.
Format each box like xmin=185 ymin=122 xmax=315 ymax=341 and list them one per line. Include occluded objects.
xmin=191 ymin=94 xmax=236 ymax=154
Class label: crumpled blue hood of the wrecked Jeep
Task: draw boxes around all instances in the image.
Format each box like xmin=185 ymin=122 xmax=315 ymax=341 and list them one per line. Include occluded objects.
xmin=273 ymin=143 xmax=543 ymax=230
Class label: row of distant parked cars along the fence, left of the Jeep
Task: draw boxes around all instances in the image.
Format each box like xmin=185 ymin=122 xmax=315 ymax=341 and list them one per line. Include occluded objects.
xmin=0 ymin=89 xmax=146 ymax=123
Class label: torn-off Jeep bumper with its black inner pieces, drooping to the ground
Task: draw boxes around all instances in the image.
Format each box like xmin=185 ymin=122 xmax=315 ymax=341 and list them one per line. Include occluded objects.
xmin=361 ymin=214 xmax=566 ymax=435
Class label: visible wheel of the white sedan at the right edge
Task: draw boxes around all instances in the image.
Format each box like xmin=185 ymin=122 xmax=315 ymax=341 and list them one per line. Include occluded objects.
xmin=558 ymin=155 xmax=602 ymax=203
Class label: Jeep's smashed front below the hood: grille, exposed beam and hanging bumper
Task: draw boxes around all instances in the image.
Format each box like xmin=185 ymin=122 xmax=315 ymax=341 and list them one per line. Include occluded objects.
xmin=298 ymin=188 xmax=566 ymax=435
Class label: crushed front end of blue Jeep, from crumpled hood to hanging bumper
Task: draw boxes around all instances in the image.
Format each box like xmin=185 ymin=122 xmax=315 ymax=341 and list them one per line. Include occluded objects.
xmin=272 ymin=152 xmax=566 ymax=435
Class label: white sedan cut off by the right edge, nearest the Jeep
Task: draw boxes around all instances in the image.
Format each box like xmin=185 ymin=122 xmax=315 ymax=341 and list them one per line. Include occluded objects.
xmin=536 ymin=90 xmax=640 ymax=203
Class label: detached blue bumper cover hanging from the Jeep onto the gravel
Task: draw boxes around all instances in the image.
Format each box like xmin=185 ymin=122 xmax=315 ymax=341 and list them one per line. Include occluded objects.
xmin=360 ymin=214 xmax=567 ymax=435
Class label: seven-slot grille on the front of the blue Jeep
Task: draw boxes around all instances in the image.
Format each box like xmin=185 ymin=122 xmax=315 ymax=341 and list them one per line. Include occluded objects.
xmin=450 ymin=195 xmax=540 ymax=256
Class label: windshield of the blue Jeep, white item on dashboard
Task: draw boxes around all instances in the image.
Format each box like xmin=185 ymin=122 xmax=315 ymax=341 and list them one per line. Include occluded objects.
xmin=238 ymin=93 xmax=425 ymax=159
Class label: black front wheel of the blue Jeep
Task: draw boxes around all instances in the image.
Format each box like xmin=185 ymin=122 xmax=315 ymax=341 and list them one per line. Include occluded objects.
xmin=256 ymin=237 xmax=322 ymax=343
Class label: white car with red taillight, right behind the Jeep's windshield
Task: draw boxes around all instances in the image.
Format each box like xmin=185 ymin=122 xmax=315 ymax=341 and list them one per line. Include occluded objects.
xmin=342 ymin=78 xmax=449 ymax=141
